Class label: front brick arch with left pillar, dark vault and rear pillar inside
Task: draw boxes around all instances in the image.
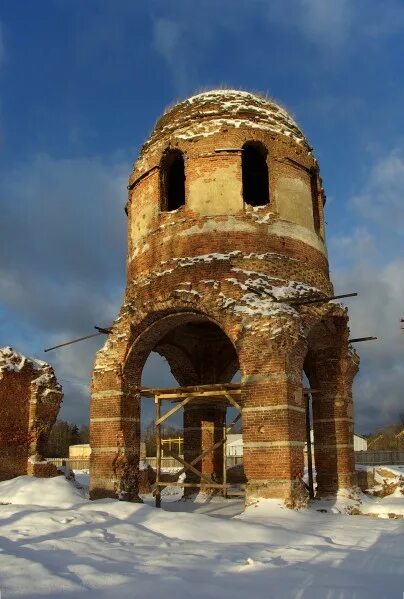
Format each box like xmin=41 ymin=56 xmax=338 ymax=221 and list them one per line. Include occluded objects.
xmin=90 ymin=306 xmax=238 ymax=499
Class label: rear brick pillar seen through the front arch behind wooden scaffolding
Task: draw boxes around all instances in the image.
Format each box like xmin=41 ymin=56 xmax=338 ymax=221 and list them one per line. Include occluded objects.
xmin=184 ymin=400 xmax=226 ymax=494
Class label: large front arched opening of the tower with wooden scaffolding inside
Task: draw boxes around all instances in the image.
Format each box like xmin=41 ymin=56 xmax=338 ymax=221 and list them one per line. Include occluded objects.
xmin=124 ymin=313 xmax=241 ymax=504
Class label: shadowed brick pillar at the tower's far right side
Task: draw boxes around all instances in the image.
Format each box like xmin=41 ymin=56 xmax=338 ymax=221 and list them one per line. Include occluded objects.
xmin=312 ymin=345 xmax=359 ymax=497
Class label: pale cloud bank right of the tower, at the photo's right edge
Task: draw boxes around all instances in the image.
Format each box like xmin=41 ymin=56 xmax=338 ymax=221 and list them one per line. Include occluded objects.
xmin=330 ymin=151 xmax=404 ymax=432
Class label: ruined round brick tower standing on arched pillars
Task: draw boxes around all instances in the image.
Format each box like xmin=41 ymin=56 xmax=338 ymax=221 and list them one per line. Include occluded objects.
xmin=90 ymin=90 xmax=358 ymax=500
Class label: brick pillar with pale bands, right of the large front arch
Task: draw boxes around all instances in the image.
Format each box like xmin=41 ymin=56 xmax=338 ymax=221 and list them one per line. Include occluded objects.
xmin=240 ymin=341 xmax=306 ymax=507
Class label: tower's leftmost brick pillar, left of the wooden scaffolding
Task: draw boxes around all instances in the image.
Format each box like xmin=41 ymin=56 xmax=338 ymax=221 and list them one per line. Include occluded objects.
xmin=90 ymin=364 xmax=140 ymax=500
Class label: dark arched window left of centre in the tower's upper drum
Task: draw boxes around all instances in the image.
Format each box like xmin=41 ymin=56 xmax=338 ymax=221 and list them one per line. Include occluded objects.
xmin=161 ymin=150 xmax=185 ymax=212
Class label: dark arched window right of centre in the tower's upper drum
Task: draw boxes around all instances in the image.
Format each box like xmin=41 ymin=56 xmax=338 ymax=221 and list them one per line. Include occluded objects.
xmin=241 ymin=142 xmax=269 ymax=206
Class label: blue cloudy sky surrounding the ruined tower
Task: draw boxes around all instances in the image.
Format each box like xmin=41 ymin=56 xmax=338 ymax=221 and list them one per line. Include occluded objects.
xmin=0 ymin=0 xmax=404 ymax=432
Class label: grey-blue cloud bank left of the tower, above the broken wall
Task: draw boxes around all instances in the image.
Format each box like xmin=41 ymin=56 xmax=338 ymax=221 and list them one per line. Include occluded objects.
xmin=0 ymin=154 xmax=129 ymax=422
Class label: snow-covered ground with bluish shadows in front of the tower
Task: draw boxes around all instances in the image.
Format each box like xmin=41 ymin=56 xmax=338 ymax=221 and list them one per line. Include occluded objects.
xmin=0 ymin=473 xmax=404 ymax=599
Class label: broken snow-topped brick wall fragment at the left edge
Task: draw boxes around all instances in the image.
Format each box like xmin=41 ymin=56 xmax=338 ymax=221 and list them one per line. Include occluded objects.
xmin=0 ymin=347 xmax=63 ymax=480
